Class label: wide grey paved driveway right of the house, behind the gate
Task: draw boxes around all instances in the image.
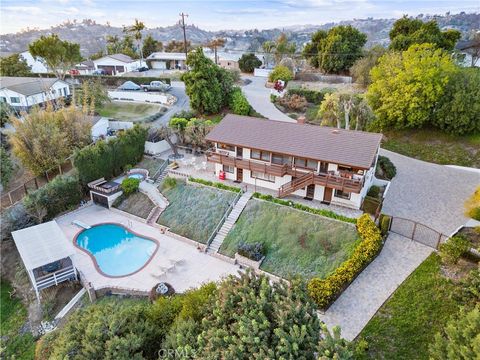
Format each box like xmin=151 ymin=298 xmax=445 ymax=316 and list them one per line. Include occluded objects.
xmin=380 ymin=149 xmax=480 ymax=235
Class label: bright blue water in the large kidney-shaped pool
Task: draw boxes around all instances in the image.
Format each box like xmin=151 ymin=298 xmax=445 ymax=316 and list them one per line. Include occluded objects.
xmin=76 ymin=224 xmax=157 ymax=276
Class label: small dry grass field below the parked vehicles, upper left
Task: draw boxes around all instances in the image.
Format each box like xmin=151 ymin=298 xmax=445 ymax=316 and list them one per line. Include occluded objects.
xmin=95 ymin=101 xmax=165 ymax=121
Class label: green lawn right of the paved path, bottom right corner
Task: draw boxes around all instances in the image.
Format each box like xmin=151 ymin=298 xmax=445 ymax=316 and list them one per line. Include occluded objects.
xmin=360 ymin=254 xmax=458 ymax=360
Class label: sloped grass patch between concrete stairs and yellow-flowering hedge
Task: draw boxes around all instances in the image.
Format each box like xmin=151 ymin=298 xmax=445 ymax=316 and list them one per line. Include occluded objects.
xmin=220 ymin=199 xmax=358 ymax=278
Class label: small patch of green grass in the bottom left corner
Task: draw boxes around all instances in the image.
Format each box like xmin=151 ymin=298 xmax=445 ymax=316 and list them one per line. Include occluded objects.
xmin=0 ymin=280 xmax=35 ymax=360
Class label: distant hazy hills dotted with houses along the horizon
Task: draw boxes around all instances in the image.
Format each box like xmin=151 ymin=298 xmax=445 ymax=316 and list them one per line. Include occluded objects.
xmin=0 ymin=12 xmax=480 ymax=57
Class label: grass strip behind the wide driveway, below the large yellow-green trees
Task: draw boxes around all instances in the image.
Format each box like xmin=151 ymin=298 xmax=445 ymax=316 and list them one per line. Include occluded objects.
xmin=382 ymin=129 xmax=480 ymax=167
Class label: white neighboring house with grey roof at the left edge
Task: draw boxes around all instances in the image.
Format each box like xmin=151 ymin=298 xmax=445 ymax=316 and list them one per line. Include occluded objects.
xmin=0 ymin=76 xmax=70 ymax=111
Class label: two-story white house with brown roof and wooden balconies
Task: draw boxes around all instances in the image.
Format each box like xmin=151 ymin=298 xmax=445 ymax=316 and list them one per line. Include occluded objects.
xmin=206 ymin=114 xmax=382 ymax=209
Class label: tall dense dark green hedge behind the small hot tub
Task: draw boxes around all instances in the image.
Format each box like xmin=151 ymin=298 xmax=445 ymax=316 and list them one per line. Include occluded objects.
xmin=73 ymin=125 xmax=147 ymax=184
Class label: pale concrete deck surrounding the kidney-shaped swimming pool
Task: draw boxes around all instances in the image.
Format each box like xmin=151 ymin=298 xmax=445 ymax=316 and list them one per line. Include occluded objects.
xmin=56 ymin=205 xmax=240 ymax=292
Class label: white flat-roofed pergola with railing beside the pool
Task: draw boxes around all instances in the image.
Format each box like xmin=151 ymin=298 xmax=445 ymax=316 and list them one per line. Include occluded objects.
xmin=12 ymin=221 xmax=77 ymax=301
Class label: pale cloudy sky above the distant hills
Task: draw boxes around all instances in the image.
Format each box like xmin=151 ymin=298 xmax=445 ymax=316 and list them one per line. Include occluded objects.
xmin=0 ymin=0 xmax=480 ymax=34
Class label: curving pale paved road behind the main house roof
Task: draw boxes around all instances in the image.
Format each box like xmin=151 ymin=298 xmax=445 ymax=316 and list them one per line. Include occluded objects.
xmin=242 ymin=76 xmax=295 ymax=122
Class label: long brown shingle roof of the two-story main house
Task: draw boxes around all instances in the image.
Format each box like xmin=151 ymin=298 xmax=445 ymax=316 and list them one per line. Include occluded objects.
xmin=206 ymin=114 xmax=382 ymax=169
